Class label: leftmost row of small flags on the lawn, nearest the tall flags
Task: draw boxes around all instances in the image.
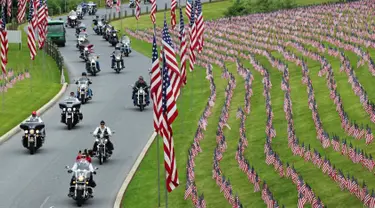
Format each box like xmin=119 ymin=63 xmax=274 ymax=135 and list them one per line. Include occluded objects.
xmin=184 ymin=65 xmax=216 ymax=208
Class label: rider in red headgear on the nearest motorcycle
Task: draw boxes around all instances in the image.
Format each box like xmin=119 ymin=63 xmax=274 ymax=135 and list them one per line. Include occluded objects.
xmin=68 ymin=153 xmax=96 ymax=197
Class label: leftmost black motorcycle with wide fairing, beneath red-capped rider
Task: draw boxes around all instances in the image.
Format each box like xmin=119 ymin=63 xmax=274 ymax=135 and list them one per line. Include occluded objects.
xmin=20 ymin=121 xmax=45 ymax=155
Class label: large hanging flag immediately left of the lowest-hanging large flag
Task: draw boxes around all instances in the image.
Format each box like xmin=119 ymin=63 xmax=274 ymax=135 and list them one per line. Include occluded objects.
xmin=151 ymin=34 xmax=162 ymax=135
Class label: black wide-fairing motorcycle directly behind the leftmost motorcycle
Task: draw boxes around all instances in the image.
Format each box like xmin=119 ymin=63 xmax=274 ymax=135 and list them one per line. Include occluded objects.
xmin=59 ymin=98 xmax=83 ymax=130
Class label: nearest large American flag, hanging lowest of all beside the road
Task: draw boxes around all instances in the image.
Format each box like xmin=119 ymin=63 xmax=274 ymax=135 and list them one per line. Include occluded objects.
xmin=160 ymin=44 xmax=179 ymax=192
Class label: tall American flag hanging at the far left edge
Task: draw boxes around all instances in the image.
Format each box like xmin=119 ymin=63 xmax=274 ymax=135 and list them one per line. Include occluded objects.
xmin=0 ymin=7 xmax=9 ymax=77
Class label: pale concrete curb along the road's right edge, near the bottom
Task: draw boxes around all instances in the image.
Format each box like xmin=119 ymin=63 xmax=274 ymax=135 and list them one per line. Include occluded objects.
xmin=113 ymin=132 xmax=157 ymax=208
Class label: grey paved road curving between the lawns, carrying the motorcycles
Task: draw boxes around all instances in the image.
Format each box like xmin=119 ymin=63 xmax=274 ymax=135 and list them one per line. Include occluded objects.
xmin=0 ymin=0 xmax=175 ymax=208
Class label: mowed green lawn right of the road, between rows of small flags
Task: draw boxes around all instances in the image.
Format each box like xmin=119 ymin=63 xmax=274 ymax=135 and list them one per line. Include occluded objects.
xmin=108 ymin=1 xmax=375 ymax=207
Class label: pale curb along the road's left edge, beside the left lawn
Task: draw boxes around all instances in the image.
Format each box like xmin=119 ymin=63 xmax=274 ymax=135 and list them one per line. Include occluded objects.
xmin=0 ymin=82 xmax=68 ymax=145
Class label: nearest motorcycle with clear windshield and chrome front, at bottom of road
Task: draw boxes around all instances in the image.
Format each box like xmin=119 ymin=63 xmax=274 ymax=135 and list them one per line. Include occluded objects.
xmin=65 ymin=162 xmax=99 ymax=207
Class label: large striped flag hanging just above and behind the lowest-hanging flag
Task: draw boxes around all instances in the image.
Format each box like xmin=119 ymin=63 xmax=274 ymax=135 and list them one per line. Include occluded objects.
xmin=162 ymin=17 xmax=181 ymax=100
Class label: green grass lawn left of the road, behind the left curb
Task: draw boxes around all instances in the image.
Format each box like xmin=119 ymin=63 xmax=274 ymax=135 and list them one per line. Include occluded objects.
xmin=0 ymin=26 xmax=67 ymax=136
